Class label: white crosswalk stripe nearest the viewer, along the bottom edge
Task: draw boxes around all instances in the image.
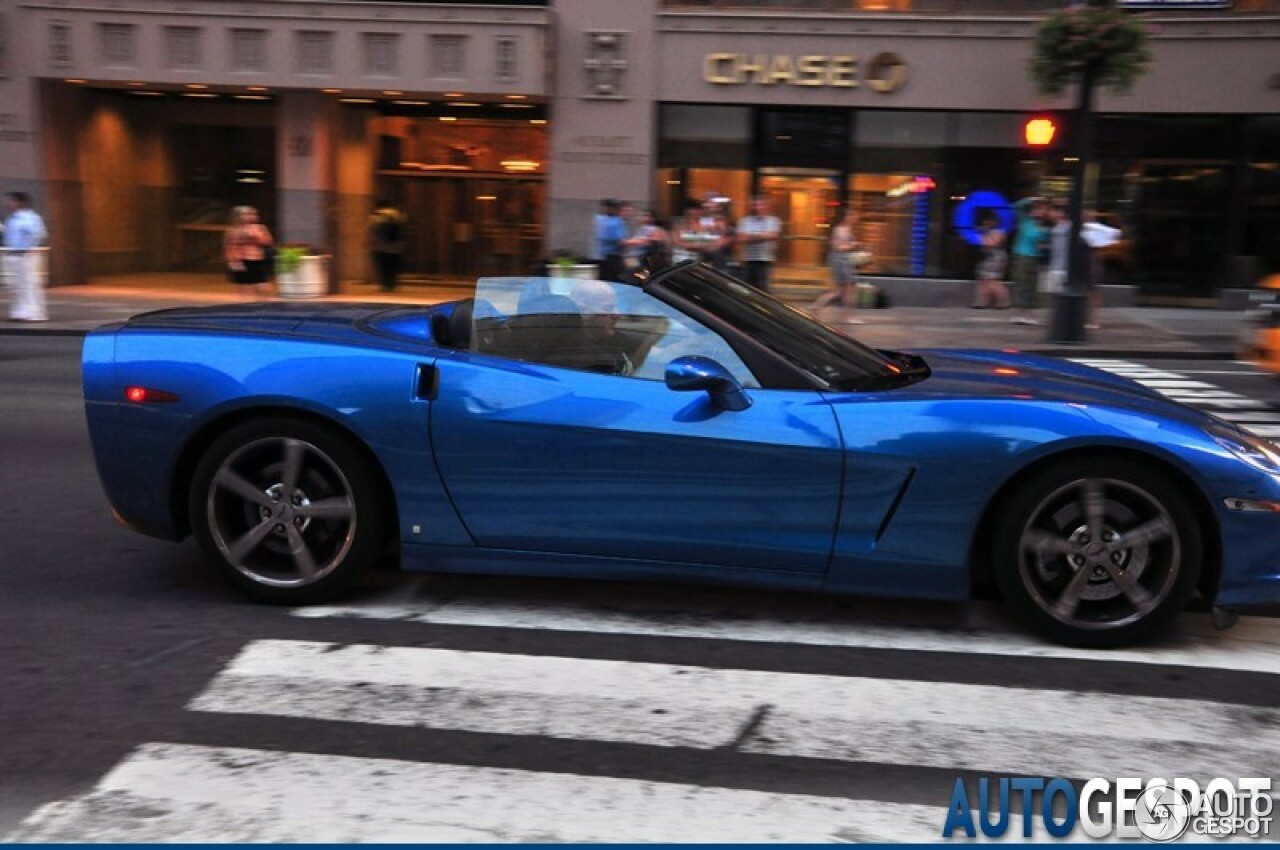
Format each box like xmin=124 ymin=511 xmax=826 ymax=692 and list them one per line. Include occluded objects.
xmin=9 ymin=744 xmax=946 ymax=844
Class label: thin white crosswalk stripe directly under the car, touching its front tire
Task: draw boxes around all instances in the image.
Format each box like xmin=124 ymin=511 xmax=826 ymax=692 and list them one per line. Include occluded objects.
xmin=292 ymin=599 xmax=1280 ymax=676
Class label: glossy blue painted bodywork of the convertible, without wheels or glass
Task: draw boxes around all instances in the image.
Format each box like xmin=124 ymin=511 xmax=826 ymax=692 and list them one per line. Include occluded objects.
xmin=83 ymin=291 xmax=1280 ymax=605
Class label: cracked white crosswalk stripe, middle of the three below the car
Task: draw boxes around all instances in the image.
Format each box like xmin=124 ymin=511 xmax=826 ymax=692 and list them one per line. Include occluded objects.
xmin=188 ymin=640 xmax=1280 ymax=780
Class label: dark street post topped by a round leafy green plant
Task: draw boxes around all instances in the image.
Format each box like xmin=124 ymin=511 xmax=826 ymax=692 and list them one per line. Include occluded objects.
xmin=1030 ymin=0 xmax=1151 ymax=342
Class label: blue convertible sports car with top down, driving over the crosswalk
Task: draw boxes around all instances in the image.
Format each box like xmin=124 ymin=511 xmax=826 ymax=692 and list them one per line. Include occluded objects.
xmin=83 ymin=265 xmax=1280 ymax=646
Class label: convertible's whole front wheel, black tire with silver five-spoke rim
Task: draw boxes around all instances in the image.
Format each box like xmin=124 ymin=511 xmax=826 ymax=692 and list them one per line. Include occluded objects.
xmin=996 ymin=458 xmax=1204 ymax=649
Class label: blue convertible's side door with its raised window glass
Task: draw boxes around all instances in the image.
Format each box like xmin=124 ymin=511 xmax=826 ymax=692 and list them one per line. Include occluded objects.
xmin=430 ymin=275 xmax=842 ymax=573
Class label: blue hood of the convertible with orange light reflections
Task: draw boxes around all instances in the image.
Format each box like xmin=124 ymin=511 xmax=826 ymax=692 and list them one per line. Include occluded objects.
xmin=895 ymin=349 xmax=1208 ymax=424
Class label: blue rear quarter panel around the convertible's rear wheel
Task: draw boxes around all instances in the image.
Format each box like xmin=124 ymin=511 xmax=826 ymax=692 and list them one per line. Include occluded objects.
xmin=86 ymin=312 xmax=471 ymax=544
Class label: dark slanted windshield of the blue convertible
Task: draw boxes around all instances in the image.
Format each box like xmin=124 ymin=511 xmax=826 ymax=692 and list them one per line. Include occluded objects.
xmin=657 ymin=265 xmax=901 ymax=390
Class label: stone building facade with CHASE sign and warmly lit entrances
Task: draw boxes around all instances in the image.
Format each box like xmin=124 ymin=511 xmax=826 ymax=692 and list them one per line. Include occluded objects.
xmin=0 ymin=0 xmax=1280 ymax=297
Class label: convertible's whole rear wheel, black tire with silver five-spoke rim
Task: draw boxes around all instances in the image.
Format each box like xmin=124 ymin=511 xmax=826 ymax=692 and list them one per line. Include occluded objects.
xmin=189 ymin=416 xmax=384 ymax=604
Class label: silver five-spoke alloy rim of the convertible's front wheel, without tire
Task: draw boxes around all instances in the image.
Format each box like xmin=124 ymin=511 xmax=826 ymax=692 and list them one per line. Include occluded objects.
xmin=1018 ymin=477 xmax=1183 ymax=630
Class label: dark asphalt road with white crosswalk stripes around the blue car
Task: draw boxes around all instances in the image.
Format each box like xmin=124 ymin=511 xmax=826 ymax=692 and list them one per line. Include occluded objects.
xmin=0 ymin=337 xmax=1280 ymax=841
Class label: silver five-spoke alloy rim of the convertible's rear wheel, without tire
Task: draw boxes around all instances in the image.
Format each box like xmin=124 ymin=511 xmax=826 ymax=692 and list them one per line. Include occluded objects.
xmin=205 ymin=437 xmax=357 ymax=588
